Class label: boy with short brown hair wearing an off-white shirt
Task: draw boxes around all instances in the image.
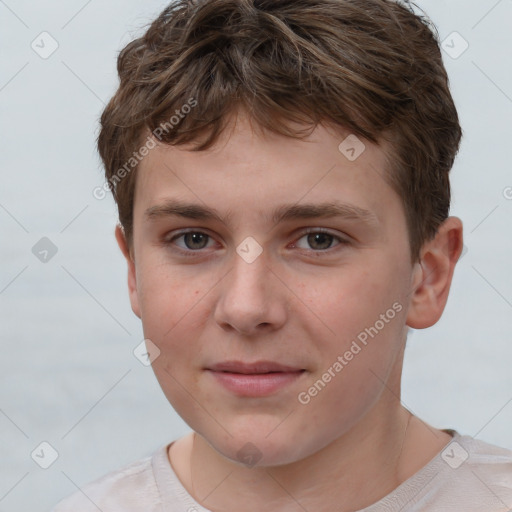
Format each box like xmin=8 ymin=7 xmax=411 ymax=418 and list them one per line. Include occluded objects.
xmin=55 ymin=0 xmax=512 ymax=512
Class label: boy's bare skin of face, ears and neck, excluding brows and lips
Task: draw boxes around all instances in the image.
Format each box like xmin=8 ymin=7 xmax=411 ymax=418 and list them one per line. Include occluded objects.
xmin=116 ymin=112 xmax=462 ymax=512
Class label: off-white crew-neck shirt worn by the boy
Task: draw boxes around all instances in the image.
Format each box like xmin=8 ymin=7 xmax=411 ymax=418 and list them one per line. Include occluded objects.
xmin=52 ymin=430 xmax=512 ymax=512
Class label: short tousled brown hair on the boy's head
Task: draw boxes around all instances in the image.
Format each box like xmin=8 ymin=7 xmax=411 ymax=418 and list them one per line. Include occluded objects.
xmin=98 ymin=0 xmax=461 ymax=261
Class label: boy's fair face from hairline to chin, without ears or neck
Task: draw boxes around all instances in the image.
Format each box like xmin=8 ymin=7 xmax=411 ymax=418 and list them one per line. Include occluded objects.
xmin=122 ymin=112 xmax=418 ymax=465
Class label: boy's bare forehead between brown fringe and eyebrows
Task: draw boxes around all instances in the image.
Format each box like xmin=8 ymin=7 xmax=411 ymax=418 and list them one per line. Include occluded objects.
xmin=134 ymin=117 xmax=400 ymax=227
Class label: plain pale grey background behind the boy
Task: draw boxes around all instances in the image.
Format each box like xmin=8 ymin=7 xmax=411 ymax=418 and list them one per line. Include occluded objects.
xmin=0 ymin=0 xmax=512 ymax=512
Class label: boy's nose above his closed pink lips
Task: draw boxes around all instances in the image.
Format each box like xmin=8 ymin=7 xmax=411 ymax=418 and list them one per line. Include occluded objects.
xmin=214 ymin=249 xmax=288 ymax=336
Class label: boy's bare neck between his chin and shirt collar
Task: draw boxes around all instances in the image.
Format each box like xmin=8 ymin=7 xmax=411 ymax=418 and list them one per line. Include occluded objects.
xmin=189 ymin=403 xmax=430 ymax=512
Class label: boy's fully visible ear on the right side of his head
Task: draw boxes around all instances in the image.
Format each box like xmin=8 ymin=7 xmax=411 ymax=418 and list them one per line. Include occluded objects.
xmin=406 ymin=217 xmax=463 ymax=329
